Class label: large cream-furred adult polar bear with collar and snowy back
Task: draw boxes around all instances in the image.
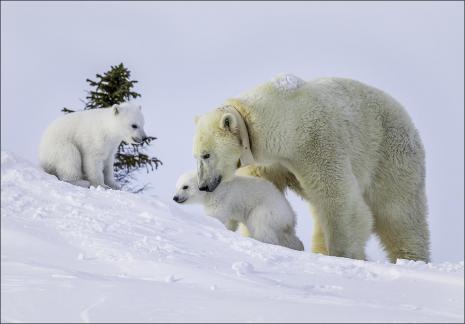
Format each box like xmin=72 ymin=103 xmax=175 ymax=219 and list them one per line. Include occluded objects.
xmin=193 ymin=75 xmax=429 ymax=262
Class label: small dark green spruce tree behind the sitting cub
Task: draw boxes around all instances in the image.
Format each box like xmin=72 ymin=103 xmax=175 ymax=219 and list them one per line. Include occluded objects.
xmin=62 ymin=63 xmax=162 ymax=185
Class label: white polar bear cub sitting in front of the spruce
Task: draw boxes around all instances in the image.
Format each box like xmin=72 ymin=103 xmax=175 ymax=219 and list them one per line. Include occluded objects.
xmin=39 ymin=103 xmax=147 ymax=189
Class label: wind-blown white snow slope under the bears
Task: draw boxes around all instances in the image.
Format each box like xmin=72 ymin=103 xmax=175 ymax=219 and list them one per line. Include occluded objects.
xmin=1 ymin=152 xmax=464 ymax=322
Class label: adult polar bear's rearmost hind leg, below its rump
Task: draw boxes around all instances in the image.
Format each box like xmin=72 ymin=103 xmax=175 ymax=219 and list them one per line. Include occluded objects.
xmin=369 ymin=125 xmax=430 ymax=262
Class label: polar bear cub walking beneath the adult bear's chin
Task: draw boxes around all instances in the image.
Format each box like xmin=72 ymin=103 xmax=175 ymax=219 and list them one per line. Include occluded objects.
xmin=173 ymin=171 xmax=304 ymax=251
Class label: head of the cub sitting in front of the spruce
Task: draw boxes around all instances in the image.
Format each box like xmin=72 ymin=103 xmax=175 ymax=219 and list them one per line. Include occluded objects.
xmin=111 ymin=103 xmax=147 ymax=144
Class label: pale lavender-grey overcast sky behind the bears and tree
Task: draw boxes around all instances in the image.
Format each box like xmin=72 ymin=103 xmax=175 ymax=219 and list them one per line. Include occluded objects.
xmin=1 ymin=2 xmax=464 ymax=261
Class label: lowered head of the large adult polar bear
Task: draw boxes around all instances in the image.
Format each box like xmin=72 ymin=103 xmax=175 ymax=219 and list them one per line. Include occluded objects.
xmin=193 ymin=108 xmax=243 ymax=192
